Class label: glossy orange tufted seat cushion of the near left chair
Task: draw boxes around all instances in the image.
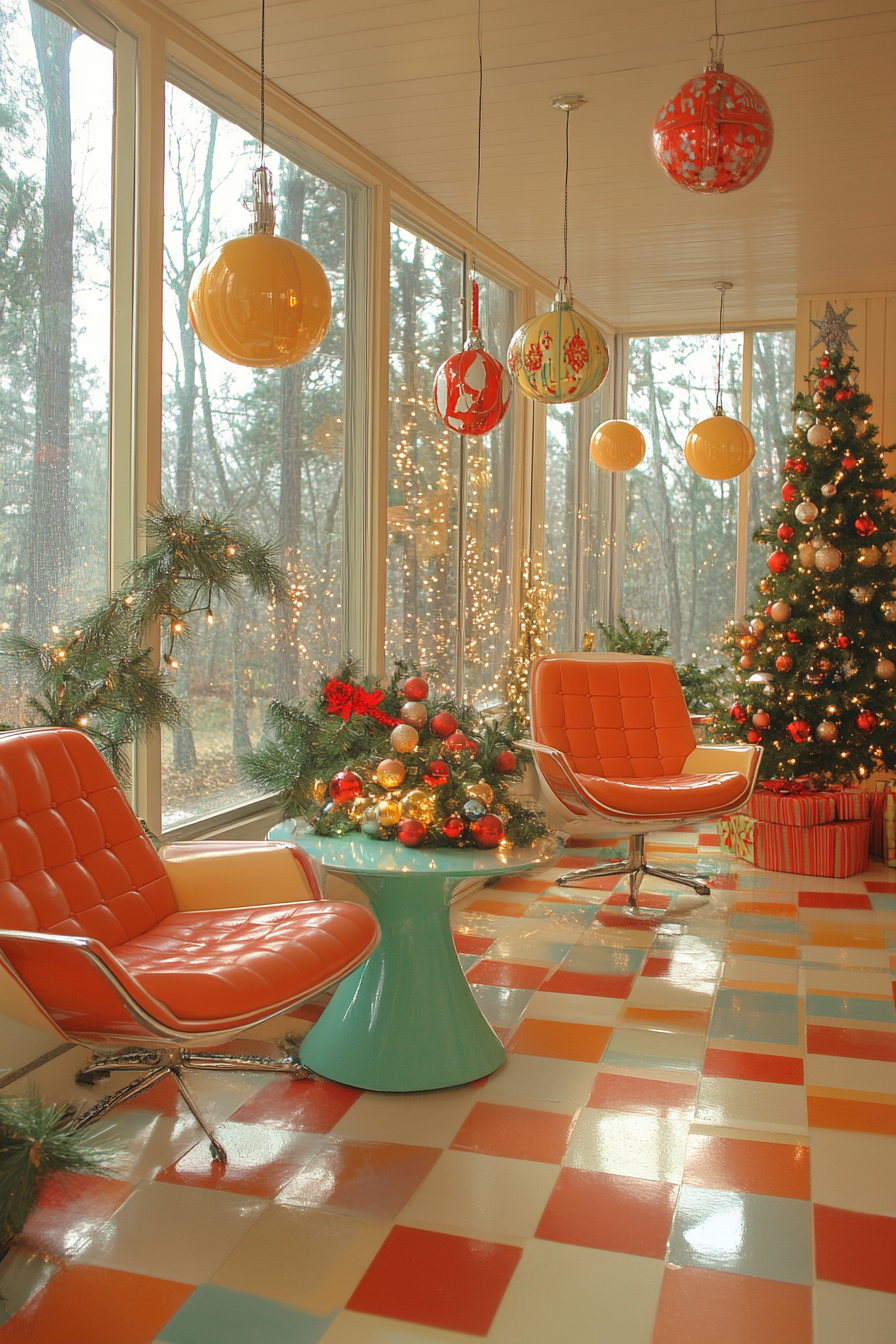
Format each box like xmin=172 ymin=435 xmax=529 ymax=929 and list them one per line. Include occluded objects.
xmin=114 ymin=900 xmax=377 ymax=1023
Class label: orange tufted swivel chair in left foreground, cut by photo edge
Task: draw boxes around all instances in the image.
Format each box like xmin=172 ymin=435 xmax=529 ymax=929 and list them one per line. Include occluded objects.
xmin=0 ymin=728 xmax=379 ymax=1161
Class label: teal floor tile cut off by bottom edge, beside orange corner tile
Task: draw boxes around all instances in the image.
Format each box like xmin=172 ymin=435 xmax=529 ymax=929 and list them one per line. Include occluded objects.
xmin=156 ymin=1284 xmax=336 ymax=1344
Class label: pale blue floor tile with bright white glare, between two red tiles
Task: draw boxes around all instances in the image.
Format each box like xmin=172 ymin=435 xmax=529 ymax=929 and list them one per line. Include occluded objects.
xmin=666 ymin=1185 xmax=813 ymax=1284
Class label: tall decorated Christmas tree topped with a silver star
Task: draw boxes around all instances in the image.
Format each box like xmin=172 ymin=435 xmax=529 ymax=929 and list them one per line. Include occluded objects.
xmin=720 ymin=304 xmax=896 ymax=784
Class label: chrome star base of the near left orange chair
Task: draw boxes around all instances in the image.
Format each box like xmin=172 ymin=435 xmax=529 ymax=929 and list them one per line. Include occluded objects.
xmin=74 ymin=1047 xmax=314 ymax=1163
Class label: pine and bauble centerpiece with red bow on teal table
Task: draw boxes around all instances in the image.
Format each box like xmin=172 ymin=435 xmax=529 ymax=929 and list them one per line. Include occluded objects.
xmin=242 ymin=659 xmax=547 ymax=849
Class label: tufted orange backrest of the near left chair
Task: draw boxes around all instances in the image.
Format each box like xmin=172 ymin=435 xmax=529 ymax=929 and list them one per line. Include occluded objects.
xmin=0 ymin=728 xmax=175 ymax=948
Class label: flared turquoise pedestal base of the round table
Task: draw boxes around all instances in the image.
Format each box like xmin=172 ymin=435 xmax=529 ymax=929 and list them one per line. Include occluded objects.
xmin=301 ymin=874 xmax=505 ymax=1091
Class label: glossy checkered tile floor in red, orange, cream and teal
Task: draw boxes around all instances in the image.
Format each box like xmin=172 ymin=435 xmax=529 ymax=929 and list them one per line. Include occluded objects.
xmin=0 ymin=832 xmax=896 ymax=1344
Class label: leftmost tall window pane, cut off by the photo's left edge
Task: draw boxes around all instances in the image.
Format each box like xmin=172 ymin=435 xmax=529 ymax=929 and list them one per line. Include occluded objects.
xmin=0 ymin=0 xmax=113 ymax=722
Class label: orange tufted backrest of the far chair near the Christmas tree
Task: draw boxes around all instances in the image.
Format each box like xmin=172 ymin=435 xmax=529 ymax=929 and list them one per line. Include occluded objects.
xmin=529 ymin=653 xmax=695 ymax=780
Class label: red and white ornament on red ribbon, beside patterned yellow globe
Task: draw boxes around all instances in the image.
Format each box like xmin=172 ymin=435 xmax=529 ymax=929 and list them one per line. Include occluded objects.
xmin=433 ymin=281 xmax=512 ymax=435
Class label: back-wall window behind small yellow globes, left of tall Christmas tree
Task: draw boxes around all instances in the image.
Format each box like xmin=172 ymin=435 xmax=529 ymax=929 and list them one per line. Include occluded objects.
xmin=622 ymin=331 xmax=794 ymax=659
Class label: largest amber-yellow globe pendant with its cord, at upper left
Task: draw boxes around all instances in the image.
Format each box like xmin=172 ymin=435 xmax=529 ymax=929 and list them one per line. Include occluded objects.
xmin=188 ymin=0 xmax=333 ymax=368
